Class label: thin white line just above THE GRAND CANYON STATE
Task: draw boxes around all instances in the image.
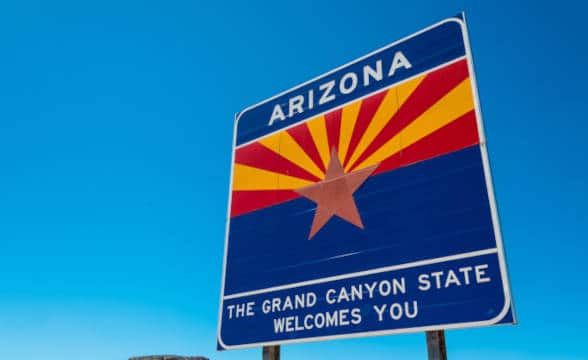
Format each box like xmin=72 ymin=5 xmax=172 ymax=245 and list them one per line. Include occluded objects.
xmin=223 ymin=248 xmax=498 ymax=300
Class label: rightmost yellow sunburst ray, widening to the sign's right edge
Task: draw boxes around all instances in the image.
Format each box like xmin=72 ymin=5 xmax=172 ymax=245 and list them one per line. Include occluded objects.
xmin=356 ymin=78 xmax=474 ymax=170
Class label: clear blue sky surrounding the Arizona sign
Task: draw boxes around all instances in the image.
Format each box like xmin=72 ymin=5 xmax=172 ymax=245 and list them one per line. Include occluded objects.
xmin=0 ymin=0 xmax=588 ymax=360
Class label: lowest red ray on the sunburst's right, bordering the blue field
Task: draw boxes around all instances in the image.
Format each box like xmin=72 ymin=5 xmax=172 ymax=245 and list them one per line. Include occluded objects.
xmin=373 ymin=110 xmax=480 ymax=175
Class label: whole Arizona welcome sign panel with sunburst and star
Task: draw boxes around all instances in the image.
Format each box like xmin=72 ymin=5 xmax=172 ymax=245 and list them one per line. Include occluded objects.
xmin=218 ymin=15 xmax=515 ymax=349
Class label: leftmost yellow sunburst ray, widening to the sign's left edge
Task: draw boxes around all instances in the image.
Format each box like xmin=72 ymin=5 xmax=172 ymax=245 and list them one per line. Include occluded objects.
xmin=233 ymin=164 xmax=312 ymax=191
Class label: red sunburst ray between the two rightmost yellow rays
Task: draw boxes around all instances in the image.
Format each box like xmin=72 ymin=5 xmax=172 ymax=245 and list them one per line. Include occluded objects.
xmin=350 ymin=59 xmax=468 ymax=171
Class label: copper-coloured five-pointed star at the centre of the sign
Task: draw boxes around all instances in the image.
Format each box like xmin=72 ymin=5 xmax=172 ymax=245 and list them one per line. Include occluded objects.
xmin=295 ymin=148 xmax=379 ymax=240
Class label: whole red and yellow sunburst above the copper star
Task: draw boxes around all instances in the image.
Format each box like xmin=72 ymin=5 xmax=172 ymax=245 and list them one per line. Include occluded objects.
xmin=231 ymin=59 xmax=479 ymax=217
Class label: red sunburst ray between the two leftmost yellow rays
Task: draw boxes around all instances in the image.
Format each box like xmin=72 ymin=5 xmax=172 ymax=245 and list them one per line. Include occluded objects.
xmin=235 ymin=143 xmax=320 ymax=181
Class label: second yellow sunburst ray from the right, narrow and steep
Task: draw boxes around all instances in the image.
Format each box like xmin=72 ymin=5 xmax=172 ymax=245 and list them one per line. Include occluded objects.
xmin=345 ymin=75 xmax=426 ymax=171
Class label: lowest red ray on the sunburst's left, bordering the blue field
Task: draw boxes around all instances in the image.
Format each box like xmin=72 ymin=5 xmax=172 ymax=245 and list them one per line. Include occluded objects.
xmin=231 ymin=190 xmax=300 ymax=217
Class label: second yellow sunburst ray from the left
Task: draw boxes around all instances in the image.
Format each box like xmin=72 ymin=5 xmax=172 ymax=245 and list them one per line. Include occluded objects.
xmin=259 ymin=130 xmax=324 ymax=179
